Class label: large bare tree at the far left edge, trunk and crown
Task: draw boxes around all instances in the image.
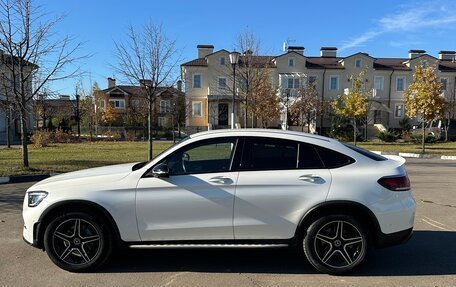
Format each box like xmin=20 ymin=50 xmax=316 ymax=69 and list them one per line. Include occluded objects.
xmin=0 ymin=0 xmax=85 ymax=167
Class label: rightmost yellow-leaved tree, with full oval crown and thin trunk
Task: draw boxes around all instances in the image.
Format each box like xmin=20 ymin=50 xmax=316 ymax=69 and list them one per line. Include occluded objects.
xmin=404 ymin=65 xmax=445 ymax=153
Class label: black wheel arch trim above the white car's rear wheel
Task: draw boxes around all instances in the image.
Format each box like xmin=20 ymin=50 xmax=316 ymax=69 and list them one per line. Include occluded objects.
xmin=295 ymin=200 xmax=381 ymax=247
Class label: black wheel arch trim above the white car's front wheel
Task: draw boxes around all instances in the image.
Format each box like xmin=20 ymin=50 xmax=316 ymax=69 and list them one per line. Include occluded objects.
xmin=33 ymin=200 xmax=122 ymax=250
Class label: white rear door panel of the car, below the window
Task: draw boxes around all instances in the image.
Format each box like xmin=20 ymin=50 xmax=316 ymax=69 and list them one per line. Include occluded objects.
xmin=233 ymin=169 xmax=331 ymax=239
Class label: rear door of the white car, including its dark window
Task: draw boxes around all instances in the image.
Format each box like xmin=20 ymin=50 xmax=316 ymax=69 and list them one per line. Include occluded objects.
xmin=233 ymin=137 xmax=331 ymax=240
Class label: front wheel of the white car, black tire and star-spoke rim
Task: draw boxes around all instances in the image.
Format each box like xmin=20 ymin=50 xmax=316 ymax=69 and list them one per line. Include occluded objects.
xmin=44 ymin=211 xmax=112 ymax=272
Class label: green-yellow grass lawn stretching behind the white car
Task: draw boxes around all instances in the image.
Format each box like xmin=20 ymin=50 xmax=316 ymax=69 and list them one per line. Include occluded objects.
xmin=0 ymin=141 xmax=456 ymax=176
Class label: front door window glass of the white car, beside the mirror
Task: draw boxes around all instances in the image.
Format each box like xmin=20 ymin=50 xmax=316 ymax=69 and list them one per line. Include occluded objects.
xmin=164 ymin=138 xmax=237 ymax=175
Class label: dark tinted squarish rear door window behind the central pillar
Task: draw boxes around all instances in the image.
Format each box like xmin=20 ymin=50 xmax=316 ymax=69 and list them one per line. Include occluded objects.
xmin=242 ymin=138 xmax=298 ymax=170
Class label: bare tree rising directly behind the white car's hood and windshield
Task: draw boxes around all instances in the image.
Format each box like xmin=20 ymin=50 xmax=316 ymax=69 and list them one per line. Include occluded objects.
xmin=113 ymin=21 xmax=180 ymax=160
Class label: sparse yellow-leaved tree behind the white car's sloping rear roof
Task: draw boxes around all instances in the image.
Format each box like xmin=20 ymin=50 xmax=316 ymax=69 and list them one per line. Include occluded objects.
xmin=331 ymin=71 xmax=369 ymax=145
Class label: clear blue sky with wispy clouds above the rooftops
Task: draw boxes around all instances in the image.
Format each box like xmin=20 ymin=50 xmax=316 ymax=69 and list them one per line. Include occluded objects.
xmin=35 ymin=0 xmax=456 ymax=96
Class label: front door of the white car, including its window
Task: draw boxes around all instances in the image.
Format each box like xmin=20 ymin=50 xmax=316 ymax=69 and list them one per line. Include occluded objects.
xmin=136 ymin=137 xmax=238 ymax=241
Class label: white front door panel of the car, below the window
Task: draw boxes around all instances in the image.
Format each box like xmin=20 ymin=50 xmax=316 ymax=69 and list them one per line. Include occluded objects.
xmin=136 ymin=172 xmax=238 ymax=241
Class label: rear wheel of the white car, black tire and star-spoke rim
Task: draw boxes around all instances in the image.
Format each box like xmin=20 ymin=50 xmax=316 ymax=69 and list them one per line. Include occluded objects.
xmin=303 ymin=215 xmax=368 ymax=275
